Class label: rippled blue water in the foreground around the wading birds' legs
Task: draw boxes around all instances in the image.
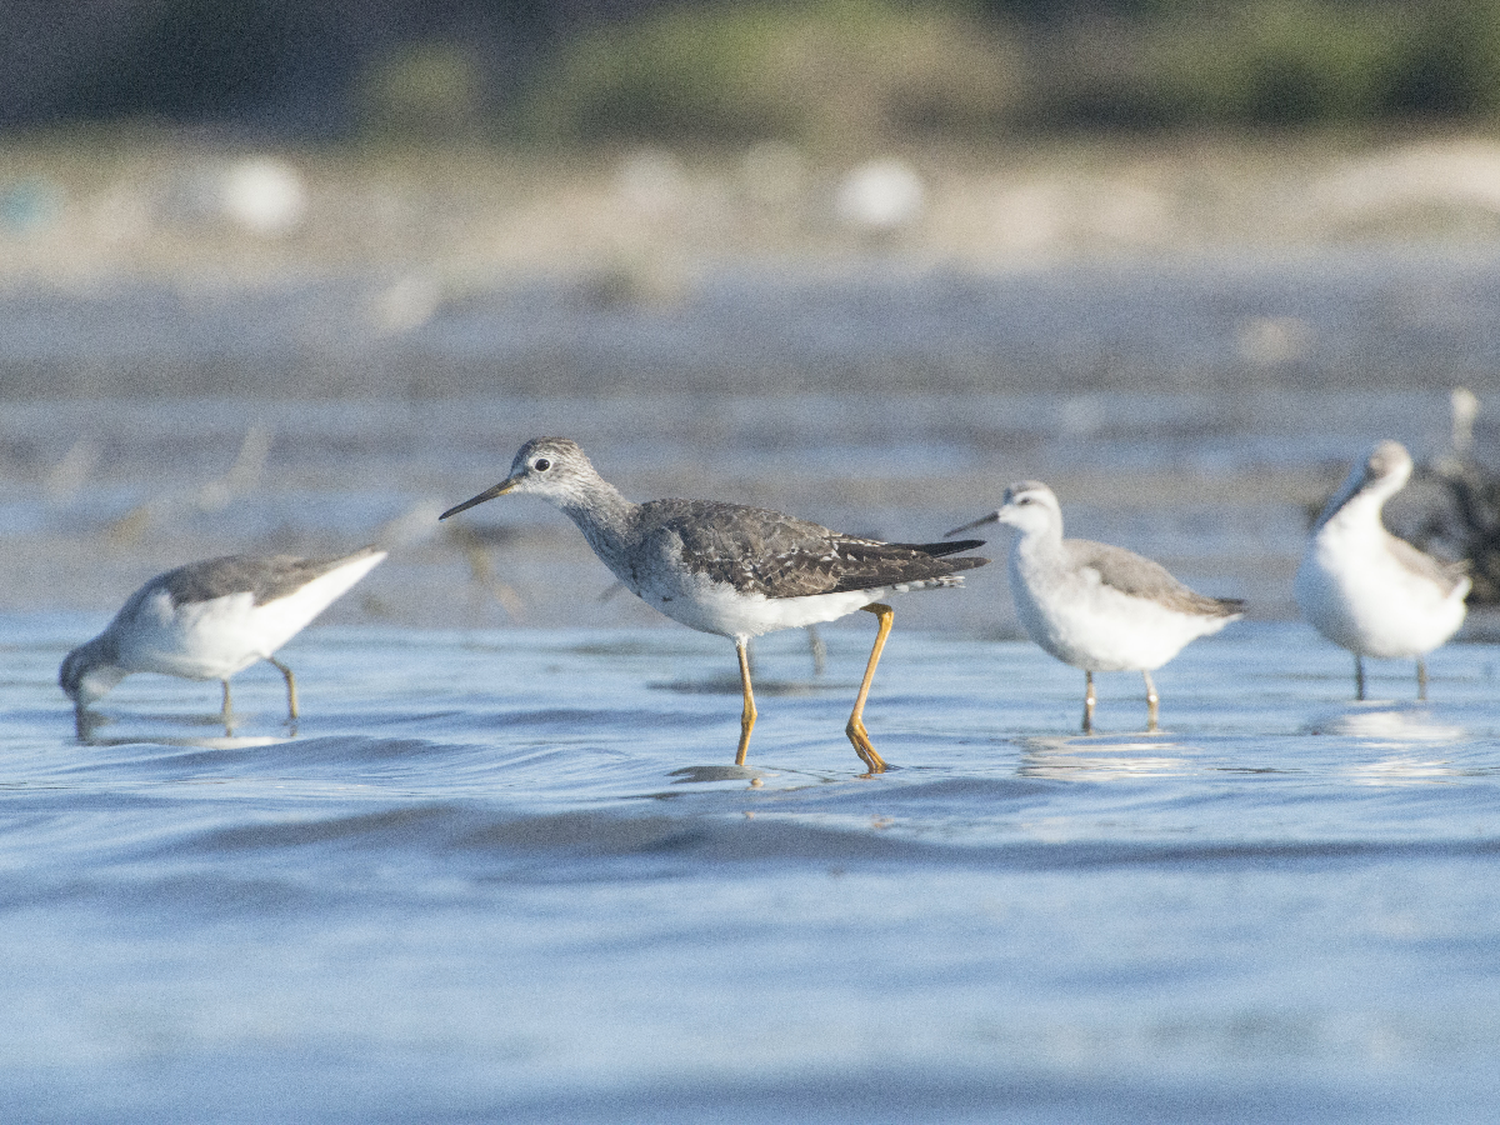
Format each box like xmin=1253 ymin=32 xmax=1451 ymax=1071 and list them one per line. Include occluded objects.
xmin=0 ymin=612 xmax=1500 ymax=1122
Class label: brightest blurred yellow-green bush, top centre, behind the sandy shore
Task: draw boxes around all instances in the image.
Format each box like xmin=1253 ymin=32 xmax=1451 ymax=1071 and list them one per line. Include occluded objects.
xmin=519 ymin=0 xmax=1022 ymax=149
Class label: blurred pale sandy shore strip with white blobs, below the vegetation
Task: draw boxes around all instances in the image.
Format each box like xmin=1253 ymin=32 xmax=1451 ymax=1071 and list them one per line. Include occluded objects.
xmin=0 ymin=132 xmax=1500 ymax=288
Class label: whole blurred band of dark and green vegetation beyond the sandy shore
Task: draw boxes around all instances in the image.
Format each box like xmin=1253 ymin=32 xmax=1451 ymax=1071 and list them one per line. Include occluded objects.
xmin=0 ymin=0 xmax=1500 ymax=150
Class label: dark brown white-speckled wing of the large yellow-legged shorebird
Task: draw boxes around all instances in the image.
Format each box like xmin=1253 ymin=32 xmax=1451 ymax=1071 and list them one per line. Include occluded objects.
xmin=641 ymin=500 xmax=989 ymax=597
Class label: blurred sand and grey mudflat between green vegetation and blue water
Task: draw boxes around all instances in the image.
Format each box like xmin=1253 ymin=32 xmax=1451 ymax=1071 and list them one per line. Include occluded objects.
xmin=0 ymin=134 xmax=1500 ymax=632
